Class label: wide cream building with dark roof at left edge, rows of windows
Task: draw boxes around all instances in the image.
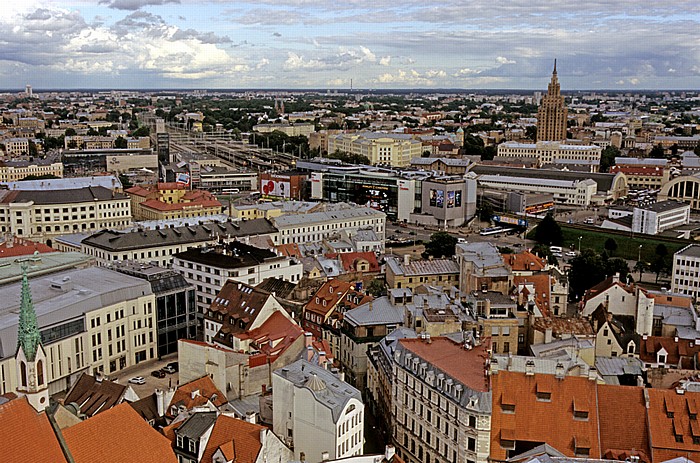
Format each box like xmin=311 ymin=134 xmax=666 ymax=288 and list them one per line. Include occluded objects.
xmin=0 ymin=187 xmax=131 ymax=242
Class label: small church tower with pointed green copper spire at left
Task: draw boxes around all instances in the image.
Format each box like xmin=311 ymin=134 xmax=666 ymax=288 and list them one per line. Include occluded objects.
xmin=15 ymin=266 xmax=49 ymax=412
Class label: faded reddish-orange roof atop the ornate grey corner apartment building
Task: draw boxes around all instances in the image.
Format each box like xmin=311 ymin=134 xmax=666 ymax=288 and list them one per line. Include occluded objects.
xmin=399 ymin=337 xmax=491 ymax=392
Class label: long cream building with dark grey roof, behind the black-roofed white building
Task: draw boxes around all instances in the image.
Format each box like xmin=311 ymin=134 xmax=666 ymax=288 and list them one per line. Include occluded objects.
xmin=81 ymin=216 xmax=278 ymax=267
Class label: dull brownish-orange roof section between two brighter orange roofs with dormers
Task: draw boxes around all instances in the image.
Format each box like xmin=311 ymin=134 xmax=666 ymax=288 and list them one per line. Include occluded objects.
xmin=598 ymin=384 xmax=651 ymax=463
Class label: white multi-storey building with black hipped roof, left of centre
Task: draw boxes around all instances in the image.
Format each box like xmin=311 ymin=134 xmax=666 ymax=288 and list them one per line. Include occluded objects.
xmin=173 ymin=241 xmax=304 ymax=310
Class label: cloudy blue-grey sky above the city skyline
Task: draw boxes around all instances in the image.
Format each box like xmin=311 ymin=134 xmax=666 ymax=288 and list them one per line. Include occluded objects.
xmin=0 ymin=0 xmax=700 ymax=90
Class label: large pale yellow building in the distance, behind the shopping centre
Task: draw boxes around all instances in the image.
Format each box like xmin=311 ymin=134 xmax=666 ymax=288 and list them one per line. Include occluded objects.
xmin=328 ymin=132 xmax=423 ymax=167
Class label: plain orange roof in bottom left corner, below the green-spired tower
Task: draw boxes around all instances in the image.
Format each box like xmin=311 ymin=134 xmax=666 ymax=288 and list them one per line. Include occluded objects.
xmin=0 ymin=397 xmax=67 ymax=463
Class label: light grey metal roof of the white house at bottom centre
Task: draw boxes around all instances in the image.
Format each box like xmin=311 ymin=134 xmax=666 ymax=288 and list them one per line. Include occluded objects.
xmin=274 ymin=359 xmax=362 ymax=422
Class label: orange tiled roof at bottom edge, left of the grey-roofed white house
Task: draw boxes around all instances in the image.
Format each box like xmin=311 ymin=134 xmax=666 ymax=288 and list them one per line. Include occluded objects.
xmin=200 ymin=415 xmax=266 ymax=463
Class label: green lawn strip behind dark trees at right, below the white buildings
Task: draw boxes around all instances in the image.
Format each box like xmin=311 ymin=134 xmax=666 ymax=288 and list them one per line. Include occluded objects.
xmin=561 ymin=225 xmax=690 ymax=262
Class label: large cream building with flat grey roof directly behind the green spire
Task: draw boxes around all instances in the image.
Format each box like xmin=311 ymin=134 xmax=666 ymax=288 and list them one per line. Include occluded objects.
xmin=0 ymin=267 xmax=157 ymax=394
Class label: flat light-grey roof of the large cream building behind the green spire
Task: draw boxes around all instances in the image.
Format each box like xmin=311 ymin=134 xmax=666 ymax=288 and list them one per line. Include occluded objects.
xmin=0 ymin=267 xmax=152 ymax=358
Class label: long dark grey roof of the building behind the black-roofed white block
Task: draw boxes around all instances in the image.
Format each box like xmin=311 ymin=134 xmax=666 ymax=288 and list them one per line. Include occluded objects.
xmin=83 ymin=219 xmax=277 ymax=252
